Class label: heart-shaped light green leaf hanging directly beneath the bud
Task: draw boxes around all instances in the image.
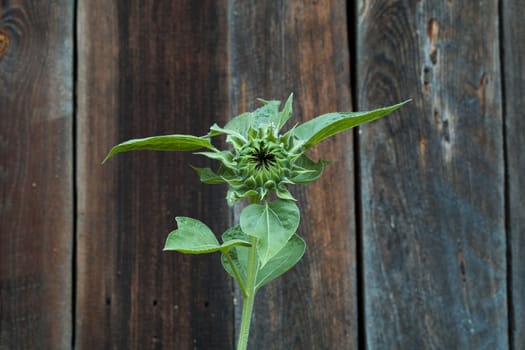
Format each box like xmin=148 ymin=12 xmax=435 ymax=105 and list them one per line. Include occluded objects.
xmin=240 ymin=199 xmax=299 ymax=266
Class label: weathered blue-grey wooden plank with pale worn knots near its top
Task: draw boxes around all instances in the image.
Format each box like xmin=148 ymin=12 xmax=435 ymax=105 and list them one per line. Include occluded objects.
xmin=357 ymin=0 xmax=508 ymax=349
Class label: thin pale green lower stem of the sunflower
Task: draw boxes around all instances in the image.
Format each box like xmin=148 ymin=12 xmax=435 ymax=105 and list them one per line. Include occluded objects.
xmin=237 ymin=236 xmax=259 ymax=350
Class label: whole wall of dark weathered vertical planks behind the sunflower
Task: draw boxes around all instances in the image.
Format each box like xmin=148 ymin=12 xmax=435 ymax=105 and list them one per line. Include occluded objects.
xmin=0 ymin=0 xmax=525 ymax=350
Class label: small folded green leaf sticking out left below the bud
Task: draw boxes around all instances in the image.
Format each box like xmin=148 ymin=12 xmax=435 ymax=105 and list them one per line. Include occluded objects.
xmin=164 ymin=216 xmax=220 ymax=254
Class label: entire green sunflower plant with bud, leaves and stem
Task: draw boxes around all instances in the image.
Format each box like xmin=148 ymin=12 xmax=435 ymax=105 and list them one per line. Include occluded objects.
xmin=104 ymin=94 xmax=408 ymax=350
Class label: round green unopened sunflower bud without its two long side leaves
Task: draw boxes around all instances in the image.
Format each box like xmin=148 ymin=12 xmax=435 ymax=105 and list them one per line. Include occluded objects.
xmin=195 ymin=96 xmax=325 ymax=205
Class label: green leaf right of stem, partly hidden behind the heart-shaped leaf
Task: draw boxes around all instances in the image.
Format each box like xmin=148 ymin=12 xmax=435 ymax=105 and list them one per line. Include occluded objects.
xmin=256 ymin=234 xmax=306 ymax=289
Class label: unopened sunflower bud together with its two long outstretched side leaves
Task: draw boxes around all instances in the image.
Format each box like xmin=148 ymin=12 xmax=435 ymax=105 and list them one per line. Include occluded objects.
xmin=104 ymin=94 xmax=408 ymax=205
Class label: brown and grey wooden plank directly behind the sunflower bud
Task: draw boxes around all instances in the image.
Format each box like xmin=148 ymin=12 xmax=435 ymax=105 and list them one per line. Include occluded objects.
xmin=230 ymin=0 xmax=357 ymax=349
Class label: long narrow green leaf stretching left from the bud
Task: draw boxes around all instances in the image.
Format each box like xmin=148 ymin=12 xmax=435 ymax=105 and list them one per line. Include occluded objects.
xmin=102 ymin=135 xmax=214 ymax=163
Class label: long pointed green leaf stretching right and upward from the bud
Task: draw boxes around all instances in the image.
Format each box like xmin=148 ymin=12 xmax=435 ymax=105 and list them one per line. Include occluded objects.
xmin=295 ymin=100 xmax=410 ymax=148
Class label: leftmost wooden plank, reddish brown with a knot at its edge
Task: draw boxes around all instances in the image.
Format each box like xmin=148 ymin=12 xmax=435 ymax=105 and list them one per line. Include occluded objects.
xmin=0 ymin=0 xmax=73 ymax=349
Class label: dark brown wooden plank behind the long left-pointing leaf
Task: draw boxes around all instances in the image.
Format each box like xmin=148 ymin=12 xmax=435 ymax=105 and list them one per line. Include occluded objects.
xmin=76 ymin=0 xmax=233 ymax=349
